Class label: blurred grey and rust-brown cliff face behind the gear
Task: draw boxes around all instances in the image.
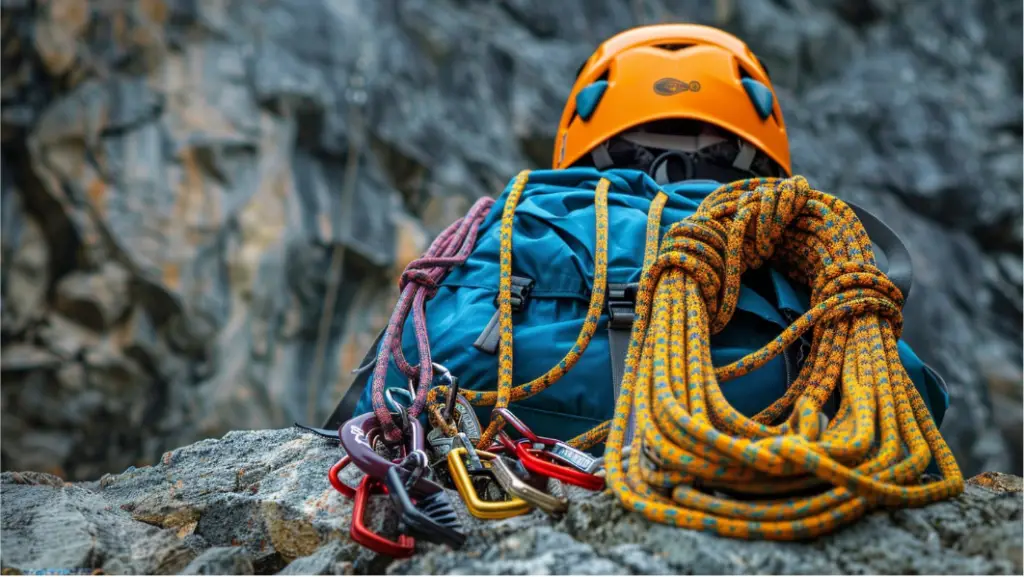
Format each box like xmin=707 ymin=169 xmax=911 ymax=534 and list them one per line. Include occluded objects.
xmin=0 ymin=0 xmax=1024 ymax=480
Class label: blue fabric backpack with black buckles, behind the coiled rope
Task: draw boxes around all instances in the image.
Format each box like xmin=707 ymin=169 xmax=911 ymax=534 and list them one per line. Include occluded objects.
xmin=325 ymin=168 xmax=949 ymax=454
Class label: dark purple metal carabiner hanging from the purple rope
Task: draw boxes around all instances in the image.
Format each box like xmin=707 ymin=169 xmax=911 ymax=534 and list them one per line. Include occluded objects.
xmin=338 ymin=413 xmax=444 ymax=495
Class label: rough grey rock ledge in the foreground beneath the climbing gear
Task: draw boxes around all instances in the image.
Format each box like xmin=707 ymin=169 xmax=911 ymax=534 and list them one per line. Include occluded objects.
xmin=0 ymin=429 xmax=1024 ymax=575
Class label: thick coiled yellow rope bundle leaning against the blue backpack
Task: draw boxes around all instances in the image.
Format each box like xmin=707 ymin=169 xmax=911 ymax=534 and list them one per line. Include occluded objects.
xmin=605 ymin=176 xmax=964 ymax=540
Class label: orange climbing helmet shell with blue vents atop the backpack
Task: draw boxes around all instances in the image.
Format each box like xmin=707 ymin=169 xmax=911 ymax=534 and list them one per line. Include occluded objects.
xmin=552 ymin=24 xmax=791 ymax=175
